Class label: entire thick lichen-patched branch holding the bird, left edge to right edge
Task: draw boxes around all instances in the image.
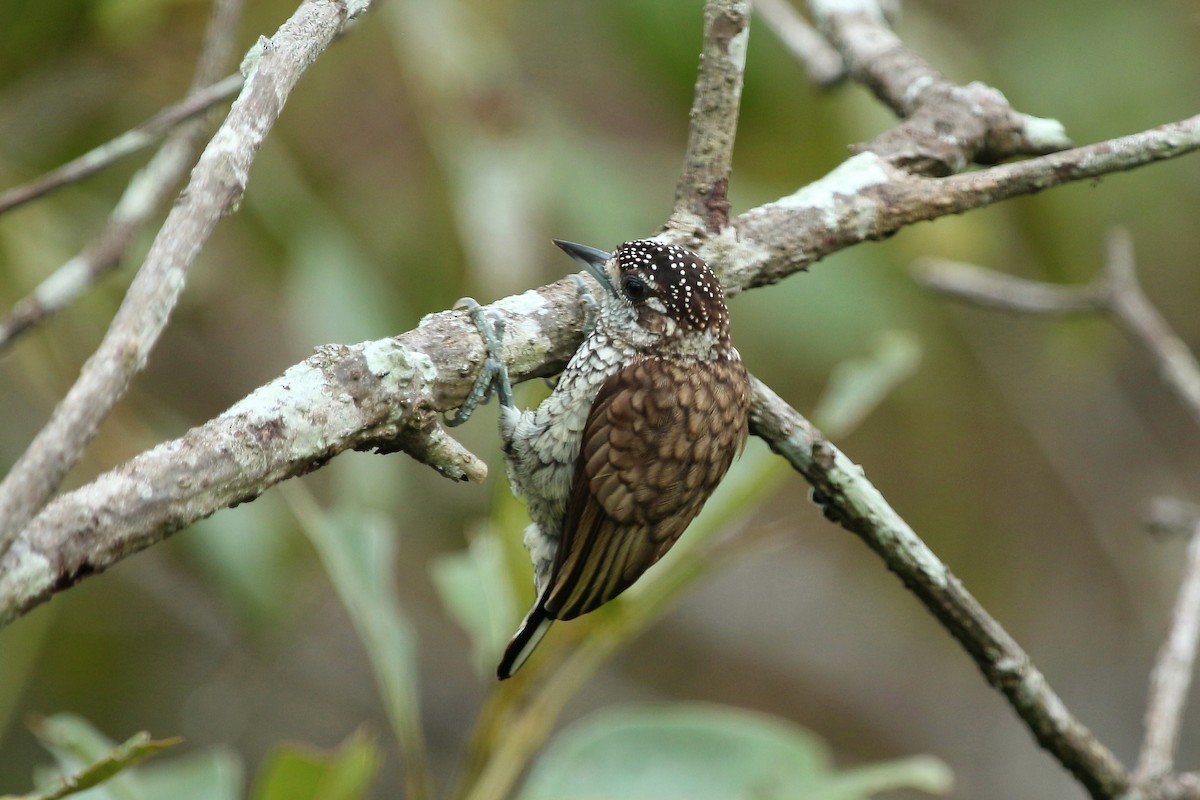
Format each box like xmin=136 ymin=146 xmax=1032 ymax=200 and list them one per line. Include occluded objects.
xmin=0 ymin=116 xmax=1200 ymax=625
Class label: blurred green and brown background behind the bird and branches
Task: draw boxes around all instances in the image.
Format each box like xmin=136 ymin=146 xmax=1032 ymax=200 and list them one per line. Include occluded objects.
xmin=0 ymin=0 xmax=1200 ymax=798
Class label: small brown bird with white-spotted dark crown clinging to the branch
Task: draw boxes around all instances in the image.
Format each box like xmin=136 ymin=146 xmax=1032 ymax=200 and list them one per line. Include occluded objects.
xmin=451 ymin=240 xmax=750 ymax=680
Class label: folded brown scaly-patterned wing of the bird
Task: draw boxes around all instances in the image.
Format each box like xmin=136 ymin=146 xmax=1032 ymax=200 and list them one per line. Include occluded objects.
xmin=541 ymin=359 xmax=749 ymax=619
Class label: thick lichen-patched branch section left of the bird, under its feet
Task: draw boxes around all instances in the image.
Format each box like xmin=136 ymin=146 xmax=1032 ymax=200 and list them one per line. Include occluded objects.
xmin=0 ymin=282 xmax=597 ymax=625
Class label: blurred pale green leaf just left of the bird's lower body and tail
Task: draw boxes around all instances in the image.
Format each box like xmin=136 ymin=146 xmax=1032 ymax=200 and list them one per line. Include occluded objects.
xmin=431 ymin=523 xmax=517 ymax=674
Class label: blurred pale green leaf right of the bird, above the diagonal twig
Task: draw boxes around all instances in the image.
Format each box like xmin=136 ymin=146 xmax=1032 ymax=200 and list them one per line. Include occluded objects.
xmin=812 ymin=331 xmax=922 ymax=437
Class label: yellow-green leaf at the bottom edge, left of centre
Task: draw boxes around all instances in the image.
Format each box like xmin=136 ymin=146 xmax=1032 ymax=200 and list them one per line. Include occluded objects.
xmin=251 ymin=729 xmax=380 ymax=800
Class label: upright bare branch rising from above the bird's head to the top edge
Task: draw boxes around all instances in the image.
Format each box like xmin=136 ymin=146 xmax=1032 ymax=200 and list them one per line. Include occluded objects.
xmin=667 ymin=0 xmax=750 ymax=233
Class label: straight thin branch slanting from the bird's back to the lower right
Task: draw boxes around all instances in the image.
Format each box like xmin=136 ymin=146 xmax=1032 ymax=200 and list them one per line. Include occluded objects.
xmin=750 ymin=380 xmax=1129 ymax=798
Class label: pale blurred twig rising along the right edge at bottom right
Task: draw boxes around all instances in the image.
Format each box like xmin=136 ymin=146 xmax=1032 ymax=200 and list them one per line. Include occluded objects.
xmin=1134 ymin=523 xmax=1200 ymax=784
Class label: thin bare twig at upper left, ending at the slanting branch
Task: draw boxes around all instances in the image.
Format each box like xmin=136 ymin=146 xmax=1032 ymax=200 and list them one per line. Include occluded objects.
xmin=0 ymin=74 xmax=242 ymax=213
